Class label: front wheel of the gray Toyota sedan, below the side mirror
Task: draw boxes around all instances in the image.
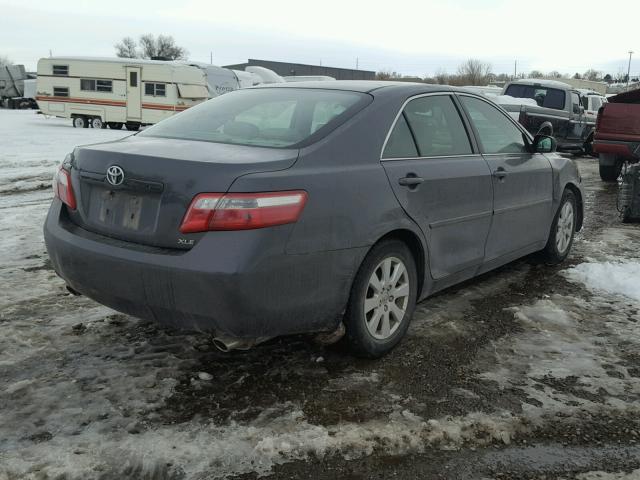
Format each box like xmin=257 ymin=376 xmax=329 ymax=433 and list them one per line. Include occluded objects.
xmin=542 ymin=189 xmax=578 ymax=265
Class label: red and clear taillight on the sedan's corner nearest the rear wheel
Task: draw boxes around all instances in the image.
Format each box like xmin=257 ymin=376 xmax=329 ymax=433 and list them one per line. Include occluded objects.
xmin=180 ymin=190 xmax=307 ymax=233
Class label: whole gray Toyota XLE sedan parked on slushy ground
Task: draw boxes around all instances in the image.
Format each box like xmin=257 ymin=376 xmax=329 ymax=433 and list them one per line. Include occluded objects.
xmin=44 ymin=81 xmax=583 ymax=357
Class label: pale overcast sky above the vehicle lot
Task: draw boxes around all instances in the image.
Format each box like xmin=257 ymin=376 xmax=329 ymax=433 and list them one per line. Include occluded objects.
xmin=0 ymin=0 xmax=640 ymax=76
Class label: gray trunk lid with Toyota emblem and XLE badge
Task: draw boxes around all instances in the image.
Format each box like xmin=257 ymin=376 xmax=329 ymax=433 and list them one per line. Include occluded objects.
xmin=70 ymin=136 xmax=298 ymax=249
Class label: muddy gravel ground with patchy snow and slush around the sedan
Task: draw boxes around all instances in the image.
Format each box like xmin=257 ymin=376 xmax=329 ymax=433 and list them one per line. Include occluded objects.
xmin=0 ymin=110 xmax=640 ymax=480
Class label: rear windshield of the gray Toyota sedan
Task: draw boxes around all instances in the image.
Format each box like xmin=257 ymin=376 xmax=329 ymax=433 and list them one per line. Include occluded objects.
xmin=139 ymin=88 xmax=371 ymax=147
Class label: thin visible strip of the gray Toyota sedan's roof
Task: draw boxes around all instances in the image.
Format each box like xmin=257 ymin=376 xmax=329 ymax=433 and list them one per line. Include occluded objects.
xmin=252 ymin=80 xmax=474 ymax=95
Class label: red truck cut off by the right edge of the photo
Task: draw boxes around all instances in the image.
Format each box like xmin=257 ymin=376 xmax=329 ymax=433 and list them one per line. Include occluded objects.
xmin=593 ymin=89 xmax=640 ymax=182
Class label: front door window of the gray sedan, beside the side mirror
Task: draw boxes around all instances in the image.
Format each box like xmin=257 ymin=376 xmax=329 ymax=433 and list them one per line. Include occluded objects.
xmin=460 ymin=95 xmax=529 ymax=154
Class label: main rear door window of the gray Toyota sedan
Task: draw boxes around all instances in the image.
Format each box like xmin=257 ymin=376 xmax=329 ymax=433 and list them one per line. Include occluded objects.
xmin=404 ymin=95 xmax=471 ymax=157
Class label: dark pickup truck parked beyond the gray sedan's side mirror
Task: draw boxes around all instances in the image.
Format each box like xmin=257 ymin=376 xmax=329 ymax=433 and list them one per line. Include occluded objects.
xmin=501 ymin=79 xmax=595 ymax=154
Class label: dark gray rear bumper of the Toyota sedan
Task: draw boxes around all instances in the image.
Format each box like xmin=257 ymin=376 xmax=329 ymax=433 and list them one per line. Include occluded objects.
xmin=44 ymin=199 xmax=366 ymax=338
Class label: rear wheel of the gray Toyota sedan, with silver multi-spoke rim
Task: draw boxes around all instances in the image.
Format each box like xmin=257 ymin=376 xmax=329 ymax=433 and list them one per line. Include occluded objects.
xmin=344 ymin=240 xmax=418 ymax=358
